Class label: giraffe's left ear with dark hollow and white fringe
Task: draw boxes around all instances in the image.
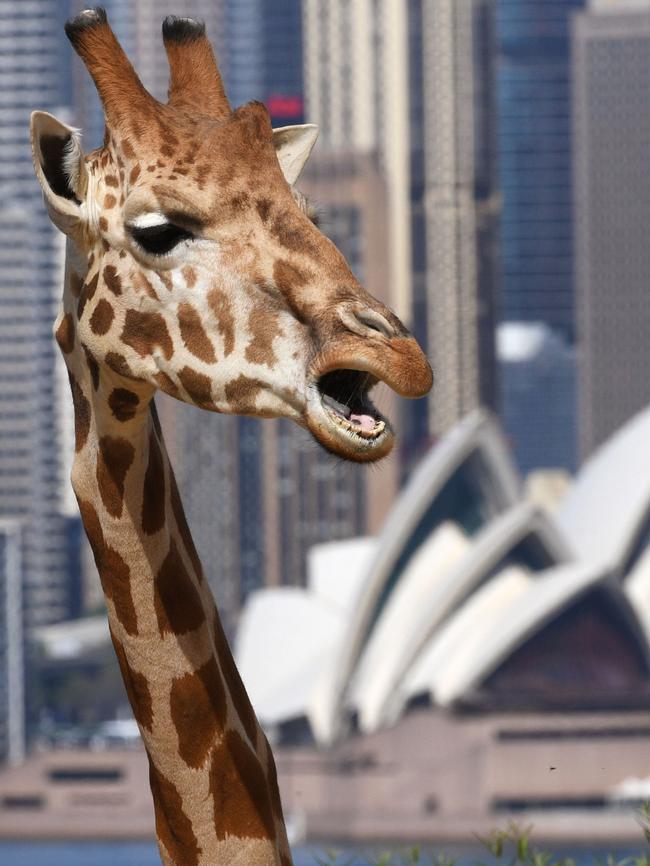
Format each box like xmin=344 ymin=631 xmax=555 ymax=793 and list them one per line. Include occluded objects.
xmin=30 ymin=111 xmax=88 ymax=234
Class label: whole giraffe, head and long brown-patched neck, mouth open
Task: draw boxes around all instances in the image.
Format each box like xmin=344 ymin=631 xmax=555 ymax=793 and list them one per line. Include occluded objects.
xmin=31 ymin=8 xmax=432 ymax=866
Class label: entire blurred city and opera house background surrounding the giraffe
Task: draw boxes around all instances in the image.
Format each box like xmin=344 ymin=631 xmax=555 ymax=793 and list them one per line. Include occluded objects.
xmin=0 ymin=0 xmax=650 ymax=863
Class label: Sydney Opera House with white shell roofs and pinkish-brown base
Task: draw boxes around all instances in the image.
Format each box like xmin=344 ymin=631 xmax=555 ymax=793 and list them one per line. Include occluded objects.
xmin=236 ymin=410 xmax=650 ymax=842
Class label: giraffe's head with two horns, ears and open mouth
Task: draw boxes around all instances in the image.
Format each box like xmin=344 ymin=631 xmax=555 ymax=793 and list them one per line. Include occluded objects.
xmin=32 ymin=9 xmax=432 ymax=461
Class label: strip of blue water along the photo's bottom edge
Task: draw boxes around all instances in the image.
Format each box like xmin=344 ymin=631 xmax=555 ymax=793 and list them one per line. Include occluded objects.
xmin=0 ymin=842 xmax=648 ymax=866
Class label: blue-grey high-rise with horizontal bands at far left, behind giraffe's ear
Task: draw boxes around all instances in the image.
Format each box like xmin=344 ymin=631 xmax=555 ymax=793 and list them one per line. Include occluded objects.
xmin=0 ymin=0 xmax=78 ymax=626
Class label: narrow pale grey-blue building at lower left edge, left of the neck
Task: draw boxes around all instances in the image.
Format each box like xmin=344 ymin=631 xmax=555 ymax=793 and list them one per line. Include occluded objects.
xmin=0 ymin=520 xmax=25 ymax=765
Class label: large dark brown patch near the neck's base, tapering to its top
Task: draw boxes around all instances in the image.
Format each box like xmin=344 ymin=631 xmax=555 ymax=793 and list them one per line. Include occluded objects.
xmin=210 ymin=731 xmax=276 ymax=840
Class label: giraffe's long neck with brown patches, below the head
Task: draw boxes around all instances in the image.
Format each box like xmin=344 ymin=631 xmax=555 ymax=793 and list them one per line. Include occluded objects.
xmin=57 ymin=258 xmax=291 ymax=866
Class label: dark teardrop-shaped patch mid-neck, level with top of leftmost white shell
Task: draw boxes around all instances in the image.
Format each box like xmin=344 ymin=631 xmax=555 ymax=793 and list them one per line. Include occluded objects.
xmin=154 ymin=538 xmax=205 ymax=636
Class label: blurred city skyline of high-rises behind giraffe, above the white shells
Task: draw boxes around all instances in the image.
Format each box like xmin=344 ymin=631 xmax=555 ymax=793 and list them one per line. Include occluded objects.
xmin=0 ymin=0 xmax=650 ymax=768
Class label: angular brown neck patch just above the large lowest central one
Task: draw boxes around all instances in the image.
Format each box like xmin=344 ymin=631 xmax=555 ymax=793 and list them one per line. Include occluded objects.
xmin=169 ymin=658 xmax=228 ymax=769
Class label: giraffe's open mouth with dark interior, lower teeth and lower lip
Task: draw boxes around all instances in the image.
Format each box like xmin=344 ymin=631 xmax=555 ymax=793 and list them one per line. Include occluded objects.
xmin=308 ymin=369 xmax=394 ymax=461
